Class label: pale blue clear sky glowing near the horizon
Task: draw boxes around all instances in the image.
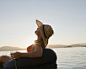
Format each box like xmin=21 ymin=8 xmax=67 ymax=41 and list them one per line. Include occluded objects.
xmin=0 ymin=0 xmax=86 ymax=48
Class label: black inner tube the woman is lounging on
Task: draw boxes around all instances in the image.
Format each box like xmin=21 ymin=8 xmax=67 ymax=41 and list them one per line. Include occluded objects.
xmin=3 ymin=49 xmax=57 ymax=69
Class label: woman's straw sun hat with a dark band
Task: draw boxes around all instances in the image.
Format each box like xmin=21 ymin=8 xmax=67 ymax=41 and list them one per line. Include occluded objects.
xmin=36 ymin=20 xmax=53 ymax=46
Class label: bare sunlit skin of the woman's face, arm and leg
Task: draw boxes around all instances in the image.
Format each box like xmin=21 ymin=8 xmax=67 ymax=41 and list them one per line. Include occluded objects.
xmin=0 ymin=28 xmax=43 ymax=64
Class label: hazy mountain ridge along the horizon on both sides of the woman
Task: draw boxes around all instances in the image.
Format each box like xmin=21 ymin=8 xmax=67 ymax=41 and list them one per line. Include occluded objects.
xmin=0 ymin=43 xmax=86 ymax=51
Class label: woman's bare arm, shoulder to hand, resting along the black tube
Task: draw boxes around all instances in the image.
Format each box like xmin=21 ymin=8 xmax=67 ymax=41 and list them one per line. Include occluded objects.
xmin=11 ymin=46 xmax=43 ymax=59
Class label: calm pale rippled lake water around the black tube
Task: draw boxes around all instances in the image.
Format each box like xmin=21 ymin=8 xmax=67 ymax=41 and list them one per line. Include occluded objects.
xmin=0 ymin=47 xmax=86 ymax=69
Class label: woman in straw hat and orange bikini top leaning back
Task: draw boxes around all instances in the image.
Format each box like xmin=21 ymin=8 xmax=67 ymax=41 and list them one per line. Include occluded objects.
xmin=0 ymin=20 xmax=53 ymax=64
